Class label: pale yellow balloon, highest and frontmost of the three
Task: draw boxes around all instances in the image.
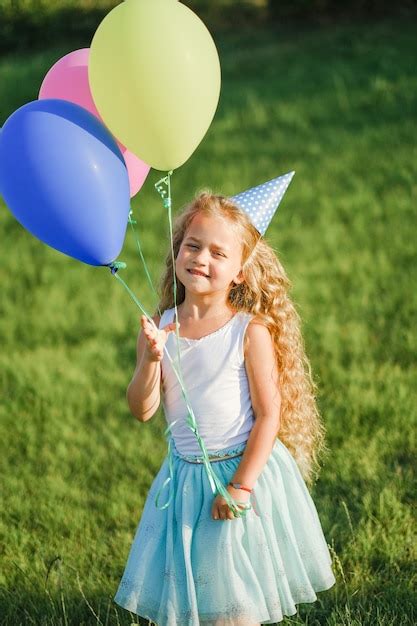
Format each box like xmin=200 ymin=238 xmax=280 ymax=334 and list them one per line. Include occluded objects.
xmin=88 ymin=0 xmax=220 ymax=170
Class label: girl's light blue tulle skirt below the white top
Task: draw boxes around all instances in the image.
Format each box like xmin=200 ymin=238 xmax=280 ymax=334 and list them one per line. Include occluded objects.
xmin=114 ymin=439 xmax=336 ymax=626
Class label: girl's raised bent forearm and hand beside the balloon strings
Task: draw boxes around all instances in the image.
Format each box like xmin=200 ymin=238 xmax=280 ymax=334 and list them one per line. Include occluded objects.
xmin=126 ymin=315 xmax=175 ymax=422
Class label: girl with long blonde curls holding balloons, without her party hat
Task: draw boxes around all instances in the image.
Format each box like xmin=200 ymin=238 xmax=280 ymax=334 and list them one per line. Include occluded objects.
xmin=115 ymin=186 xmax=335 ymax=626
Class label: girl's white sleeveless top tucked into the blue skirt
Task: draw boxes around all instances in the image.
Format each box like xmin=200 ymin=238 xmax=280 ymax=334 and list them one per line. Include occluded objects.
xmin=159 ymin=308 xmax=255 ymax=455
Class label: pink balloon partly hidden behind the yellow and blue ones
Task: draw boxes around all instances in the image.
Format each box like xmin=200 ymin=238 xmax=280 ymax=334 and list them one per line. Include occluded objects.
xmin=39 ymin=48 xmax=151 ymax=197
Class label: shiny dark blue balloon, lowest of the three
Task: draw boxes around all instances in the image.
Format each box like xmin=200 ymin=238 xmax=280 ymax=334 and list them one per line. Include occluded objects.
xmin=0 ymin=99 xmax=130 ymax=265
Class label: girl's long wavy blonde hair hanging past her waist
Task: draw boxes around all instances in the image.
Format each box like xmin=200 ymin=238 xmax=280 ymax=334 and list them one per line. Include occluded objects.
xmin=159 ymin=191 xmax=328 ymax=484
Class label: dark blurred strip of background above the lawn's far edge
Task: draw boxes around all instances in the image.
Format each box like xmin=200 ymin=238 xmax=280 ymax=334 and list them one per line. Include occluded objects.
xmin=0 ymin=0 xmax=417 ymax=52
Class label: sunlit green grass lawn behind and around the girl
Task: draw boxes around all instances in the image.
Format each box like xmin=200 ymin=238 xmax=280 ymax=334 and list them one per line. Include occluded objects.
xmin=0 ymin=14 xmax=417 ymax=626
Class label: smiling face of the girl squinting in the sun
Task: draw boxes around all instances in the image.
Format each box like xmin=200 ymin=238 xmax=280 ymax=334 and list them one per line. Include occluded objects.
xmin=175 ymin=213 xmax=243 ymax=296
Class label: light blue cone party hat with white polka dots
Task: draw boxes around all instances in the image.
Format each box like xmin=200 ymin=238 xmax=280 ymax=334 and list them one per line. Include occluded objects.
xmin=230 ymin=172 xmax=295 ymax=235
